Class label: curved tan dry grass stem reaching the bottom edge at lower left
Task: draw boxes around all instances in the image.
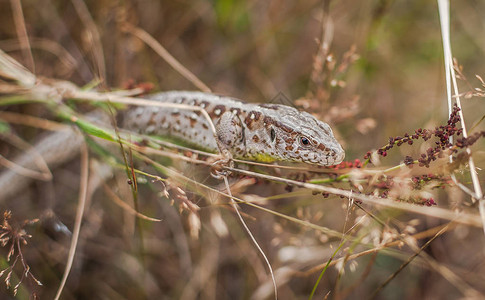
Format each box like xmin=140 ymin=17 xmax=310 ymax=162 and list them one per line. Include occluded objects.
xmin=54 ymin=144 xmax=89 ymax=300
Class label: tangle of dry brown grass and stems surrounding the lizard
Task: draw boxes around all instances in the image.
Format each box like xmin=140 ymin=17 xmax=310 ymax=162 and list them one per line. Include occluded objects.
xmin=0 ymin=0 xmax=485 ymax=299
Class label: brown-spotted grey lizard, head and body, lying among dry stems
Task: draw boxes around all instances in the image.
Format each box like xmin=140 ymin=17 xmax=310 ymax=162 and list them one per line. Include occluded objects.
xmin=122 ymin=91 xmax=345 ymax=166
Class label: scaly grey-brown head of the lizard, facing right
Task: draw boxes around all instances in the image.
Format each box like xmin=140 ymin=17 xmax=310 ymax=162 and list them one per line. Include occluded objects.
xmin=250 ymin=104 xmax=345 ymax=166
